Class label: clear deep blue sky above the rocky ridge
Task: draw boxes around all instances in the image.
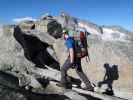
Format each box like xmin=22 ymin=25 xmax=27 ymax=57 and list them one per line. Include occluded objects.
xmin=0 ymin=0 xmax=133 ymax=31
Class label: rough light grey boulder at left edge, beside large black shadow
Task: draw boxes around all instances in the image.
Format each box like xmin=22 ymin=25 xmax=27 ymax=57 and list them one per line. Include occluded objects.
xmin=0 ymin=26 xmax=33 ymax=72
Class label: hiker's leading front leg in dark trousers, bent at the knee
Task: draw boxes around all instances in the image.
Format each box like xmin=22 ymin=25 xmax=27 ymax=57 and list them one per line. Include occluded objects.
xmin=61 ymin=58 xmax=71 ymax=87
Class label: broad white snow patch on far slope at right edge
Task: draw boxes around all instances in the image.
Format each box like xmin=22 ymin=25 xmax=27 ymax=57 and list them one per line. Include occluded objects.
xmin=101 ymin=26 xmax=133 ymax=42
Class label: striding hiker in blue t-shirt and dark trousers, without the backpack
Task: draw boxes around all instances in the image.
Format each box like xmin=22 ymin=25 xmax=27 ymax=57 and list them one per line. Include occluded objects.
xmin=61 ymin=30 xmax=94 ymax=91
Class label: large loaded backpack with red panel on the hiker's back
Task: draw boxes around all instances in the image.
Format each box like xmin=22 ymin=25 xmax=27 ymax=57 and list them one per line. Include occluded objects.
xmin=68 ymin=30 xmax=88 ymax=58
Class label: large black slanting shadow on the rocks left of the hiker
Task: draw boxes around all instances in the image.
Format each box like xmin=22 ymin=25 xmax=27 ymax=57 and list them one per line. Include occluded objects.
xmin=14 ymin=26 xmax=60 ymax=70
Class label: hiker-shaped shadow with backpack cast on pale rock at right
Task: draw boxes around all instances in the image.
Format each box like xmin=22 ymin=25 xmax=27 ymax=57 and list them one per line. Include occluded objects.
xmin=98 ymin=63 xmax=119 ymax=95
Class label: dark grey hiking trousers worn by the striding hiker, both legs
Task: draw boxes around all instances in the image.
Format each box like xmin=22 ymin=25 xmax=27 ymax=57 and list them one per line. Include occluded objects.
xmin=61 ymin=58 xmax=91 ymax=88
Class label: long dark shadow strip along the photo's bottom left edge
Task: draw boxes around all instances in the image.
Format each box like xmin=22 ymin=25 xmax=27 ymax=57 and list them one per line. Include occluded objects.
xmin=0 ymin=82 xmax=71 ymax=100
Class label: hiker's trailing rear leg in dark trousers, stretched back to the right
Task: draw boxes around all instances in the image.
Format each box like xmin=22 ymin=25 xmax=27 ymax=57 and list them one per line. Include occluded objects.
xmin=76 ymin=60 xmax=93 ymax=90
